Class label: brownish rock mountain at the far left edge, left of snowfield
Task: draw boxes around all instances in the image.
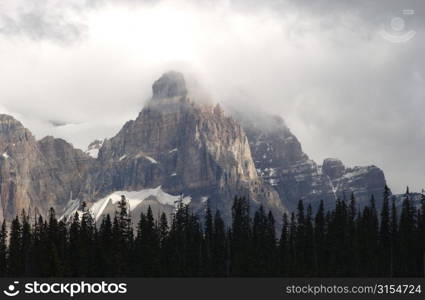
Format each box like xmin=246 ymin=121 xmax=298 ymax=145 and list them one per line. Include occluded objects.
xmin=0 ymin=115 xmax=92 ymax=220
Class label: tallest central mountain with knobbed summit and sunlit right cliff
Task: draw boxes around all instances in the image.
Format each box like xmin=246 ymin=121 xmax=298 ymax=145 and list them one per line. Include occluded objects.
xmin=85 ymin=72 xmax=285 ymax=221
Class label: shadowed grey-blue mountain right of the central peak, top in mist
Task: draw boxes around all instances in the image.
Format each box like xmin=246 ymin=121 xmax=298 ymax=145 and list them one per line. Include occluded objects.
xmin=234 ymin=112 xmax=385 ymax=210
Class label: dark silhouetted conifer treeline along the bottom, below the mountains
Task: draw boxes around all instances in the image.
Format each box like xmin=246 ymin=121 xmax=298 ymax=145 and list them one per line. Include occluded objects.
xmin=0 ymin=187 xmax=425 ymax=277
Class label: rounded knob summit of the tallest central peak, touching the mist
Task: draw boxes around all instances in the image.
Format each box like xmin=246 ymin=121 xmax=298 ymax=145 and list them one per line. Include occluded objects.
xmin=152 ymin=71 xmax=187 ymax=99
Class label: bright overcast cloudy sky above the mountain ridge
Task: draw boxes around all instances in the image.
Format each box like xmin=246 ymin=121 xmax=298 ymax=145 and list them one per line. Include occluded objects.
xmin=0 ymin=0 xmax=425 ymax=192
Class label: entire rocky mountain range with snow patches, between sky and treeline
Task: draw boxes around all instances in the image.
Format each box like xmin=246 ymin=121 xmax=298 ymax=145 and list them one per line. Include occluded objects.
xmin=0 ymin=72 xmax=385 ymax=221
